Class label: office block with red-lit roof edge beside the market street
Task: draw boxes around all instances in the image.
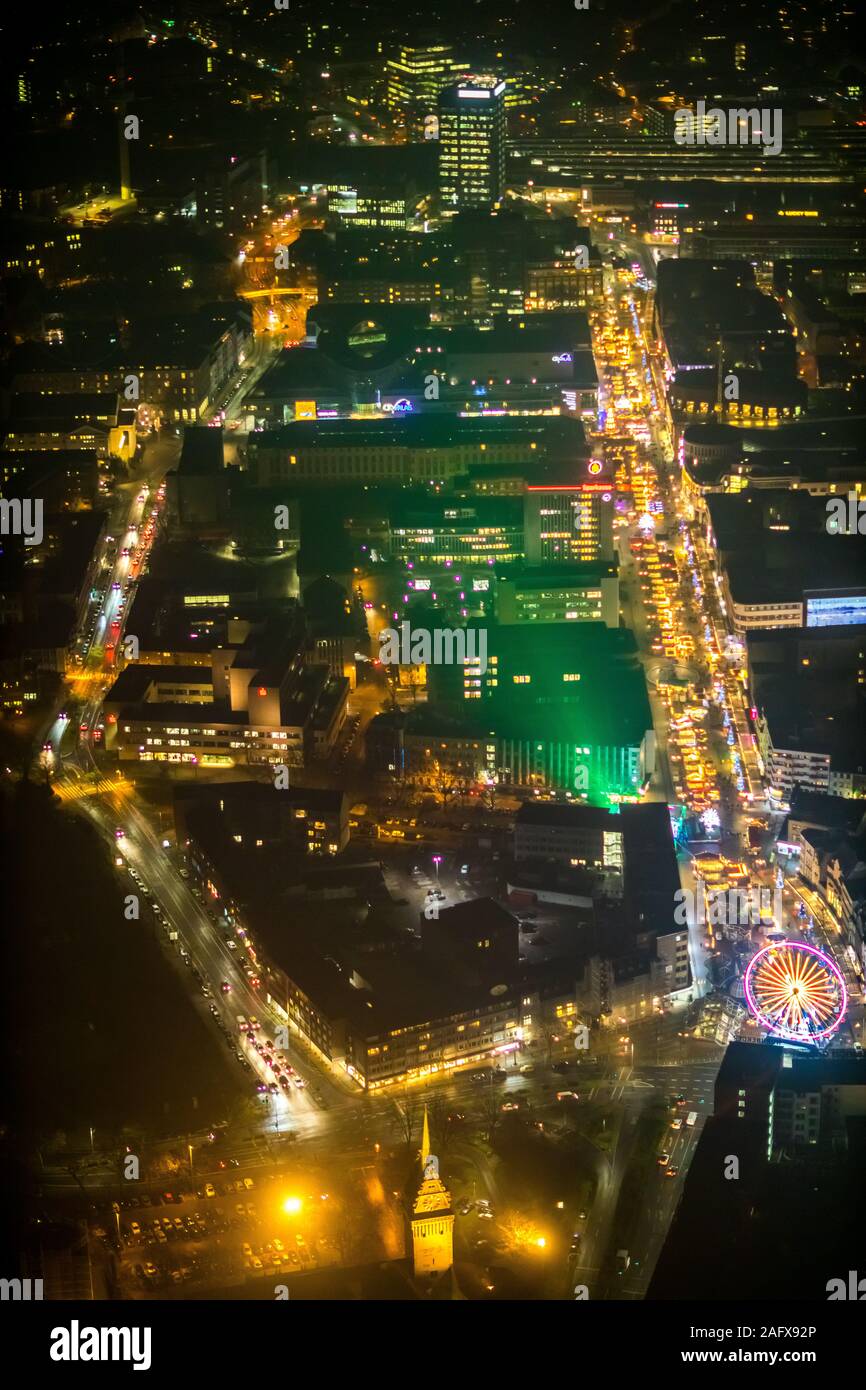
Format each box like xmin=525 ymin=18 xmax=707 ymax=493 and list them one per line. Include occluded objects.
xmin=524 ymin=482 xmax=614 ymax=564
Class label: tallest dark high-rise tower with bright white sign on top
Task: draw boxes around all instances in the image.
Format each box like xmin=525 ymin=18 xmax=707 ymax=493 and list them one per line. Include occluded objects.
xmin=439 ymin=78 xmax=505 ymax=217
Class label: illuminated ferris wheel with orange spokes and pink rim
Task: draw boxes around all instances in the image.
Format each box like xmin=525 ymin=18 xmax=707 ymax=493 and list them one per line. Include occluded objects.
xmin=744 ymin=941 xmax=848 ymax=1043
